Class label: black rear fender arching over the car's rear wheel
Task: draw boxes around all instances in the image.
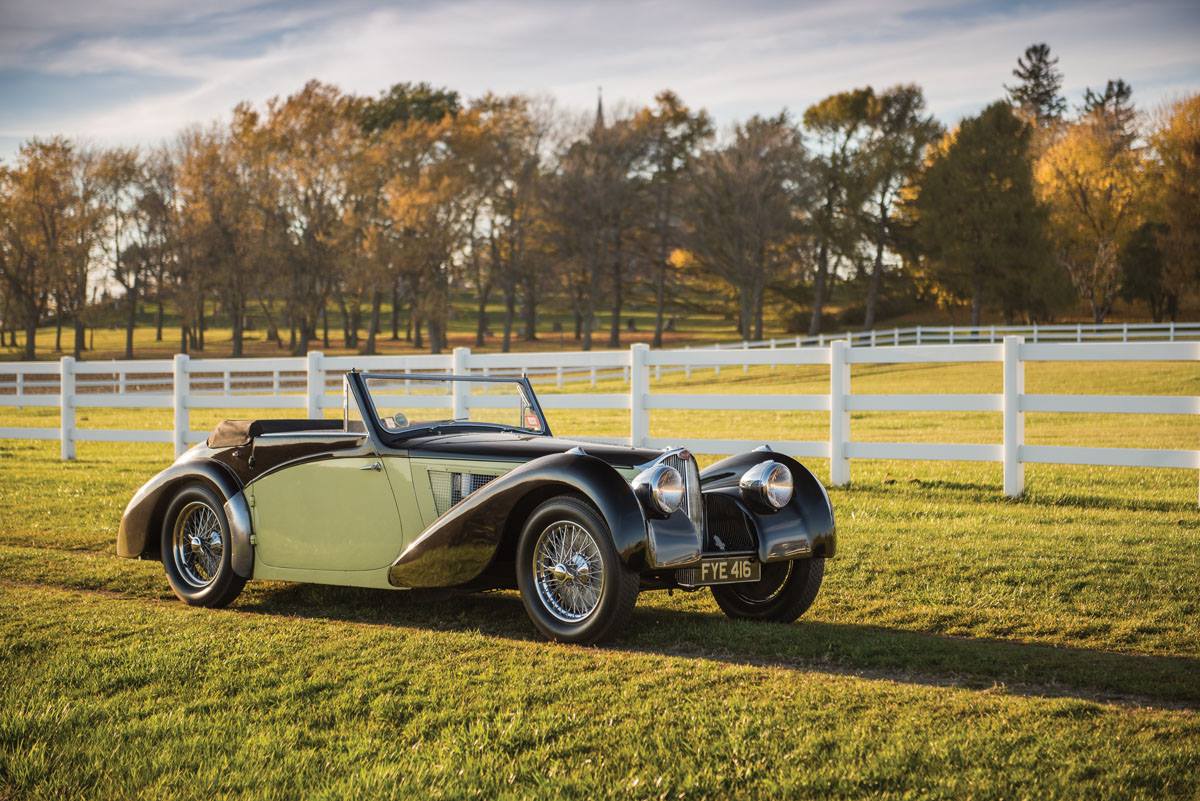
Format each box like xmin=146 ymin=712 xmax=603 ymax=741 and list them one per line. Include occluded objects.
xmin=116 ymin=457 xmax=254 ymax=578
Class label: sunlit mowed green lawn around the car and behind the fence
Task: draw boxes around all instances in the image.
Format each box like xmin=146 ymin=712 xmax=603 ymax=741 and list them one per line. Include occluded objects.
xmin=0 ymin=365 xmax=1200 ymax=800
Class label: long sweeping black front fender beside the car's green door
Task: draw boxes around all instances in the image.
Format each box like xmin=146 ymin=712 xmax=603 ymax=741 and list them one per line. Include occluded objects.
xmin=388 ymin=452 xmax=700 ymax=588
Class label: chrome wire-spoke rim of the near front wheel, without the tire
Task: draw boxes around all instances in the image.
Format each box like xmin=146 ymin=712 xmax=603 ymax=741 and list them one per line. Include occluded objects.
xmin=533 ymin=520 xmax=605 ymax=624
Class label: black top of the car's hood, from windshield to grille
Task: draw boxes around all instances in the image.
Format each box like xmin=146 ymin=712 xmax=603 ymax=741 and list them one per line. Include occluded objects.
xmin=397 ymin=432 xmax=662 ymax=468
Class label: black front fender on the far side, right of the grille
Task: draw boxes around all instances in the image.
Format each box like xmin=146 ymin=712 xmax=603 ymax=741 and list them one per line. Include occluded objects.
xmin=700 ymin=451 xmax=838 ymax=562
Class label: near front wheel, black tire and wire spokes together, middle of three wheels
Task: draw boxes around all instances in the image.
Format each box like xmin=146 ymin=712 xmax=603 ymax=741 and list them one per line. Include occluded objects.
xmin=517 ymin=495 xmax=638 ymax=643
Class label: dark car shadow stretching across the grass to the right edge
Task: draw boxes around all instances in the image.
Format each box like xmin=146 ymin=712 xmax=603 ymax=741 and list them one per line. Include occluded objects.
xmin=235 ymin=584 xmax=1200 ymax=709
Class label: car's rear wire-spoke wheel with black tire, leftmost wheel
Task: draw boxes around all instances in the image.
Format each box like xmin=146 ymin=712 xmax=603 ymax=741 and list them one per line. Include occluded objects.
xmin=160 ymin=483 xmax=246 ymax=608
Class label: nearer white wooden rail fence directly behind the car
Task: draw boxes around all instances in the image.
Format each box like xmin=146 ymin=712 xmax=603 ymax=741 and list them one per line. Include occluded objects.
xmin=0 ymin=336 xmax=1200 ymax=503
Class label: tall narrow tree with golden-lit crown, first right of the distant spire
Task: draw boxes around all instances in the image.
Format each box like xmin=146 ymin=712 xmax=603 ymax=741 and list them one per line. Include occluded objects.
xmin=634 ymin=90 xmax=713 ymax=348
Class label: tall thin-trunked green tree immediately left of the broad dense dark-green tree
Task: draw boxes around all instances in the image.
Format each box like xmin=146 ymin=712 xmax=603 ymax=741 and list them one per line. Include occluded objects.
xmin=860 ymin=84 xmax=942 ymax=329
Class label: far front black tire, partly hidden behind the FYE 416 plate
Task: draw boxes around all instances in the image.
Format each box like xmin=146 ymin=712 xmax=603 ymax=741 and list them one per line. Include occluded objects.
xmin=712 ymin=559 xmax=824 ymax=624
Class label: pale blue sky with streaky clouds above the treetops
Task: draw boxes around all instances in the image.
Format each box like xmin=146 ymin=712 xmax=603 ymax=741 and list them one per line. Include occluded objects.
xmin=0 ymin=0 xmax=1200 ymax=159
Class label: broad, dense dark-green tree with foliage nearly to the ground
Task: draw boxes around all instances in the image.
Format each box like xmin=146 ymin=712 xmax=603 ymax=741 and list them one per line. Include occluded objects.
xmin=907 ymin=102 xmax=1048 ymax=326
